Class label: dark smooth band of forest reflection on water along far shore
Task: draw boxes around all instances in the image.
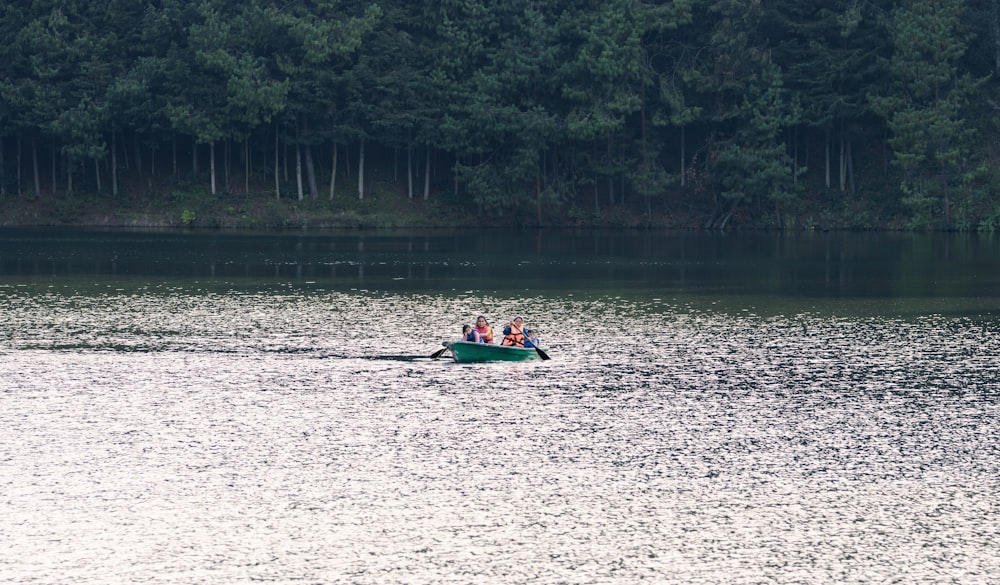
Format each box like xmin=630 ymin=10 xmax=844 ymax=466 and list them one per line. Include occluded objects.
xmin=0 ymin=230 xmax=1000 ymax=298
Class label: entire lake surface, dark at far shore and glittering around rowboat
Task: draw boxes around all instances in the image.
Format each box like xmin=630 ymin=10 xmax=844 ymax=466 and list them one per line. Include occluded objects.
xmin=0 ymin=230 xmax=1000 ymax=585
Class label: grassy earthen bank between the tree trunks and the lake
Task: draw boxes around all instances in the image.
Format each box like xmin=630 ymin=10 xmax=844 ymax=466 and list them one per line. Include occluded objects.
xmin=0 ymin=187 xmax=972 ymax=233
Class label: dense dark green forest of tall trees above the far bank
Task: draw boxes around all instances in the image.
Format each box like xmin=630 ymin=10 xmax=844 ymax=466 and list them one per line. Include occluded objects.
xmin=0 ymin=0 xmax=1000 ymax=231
